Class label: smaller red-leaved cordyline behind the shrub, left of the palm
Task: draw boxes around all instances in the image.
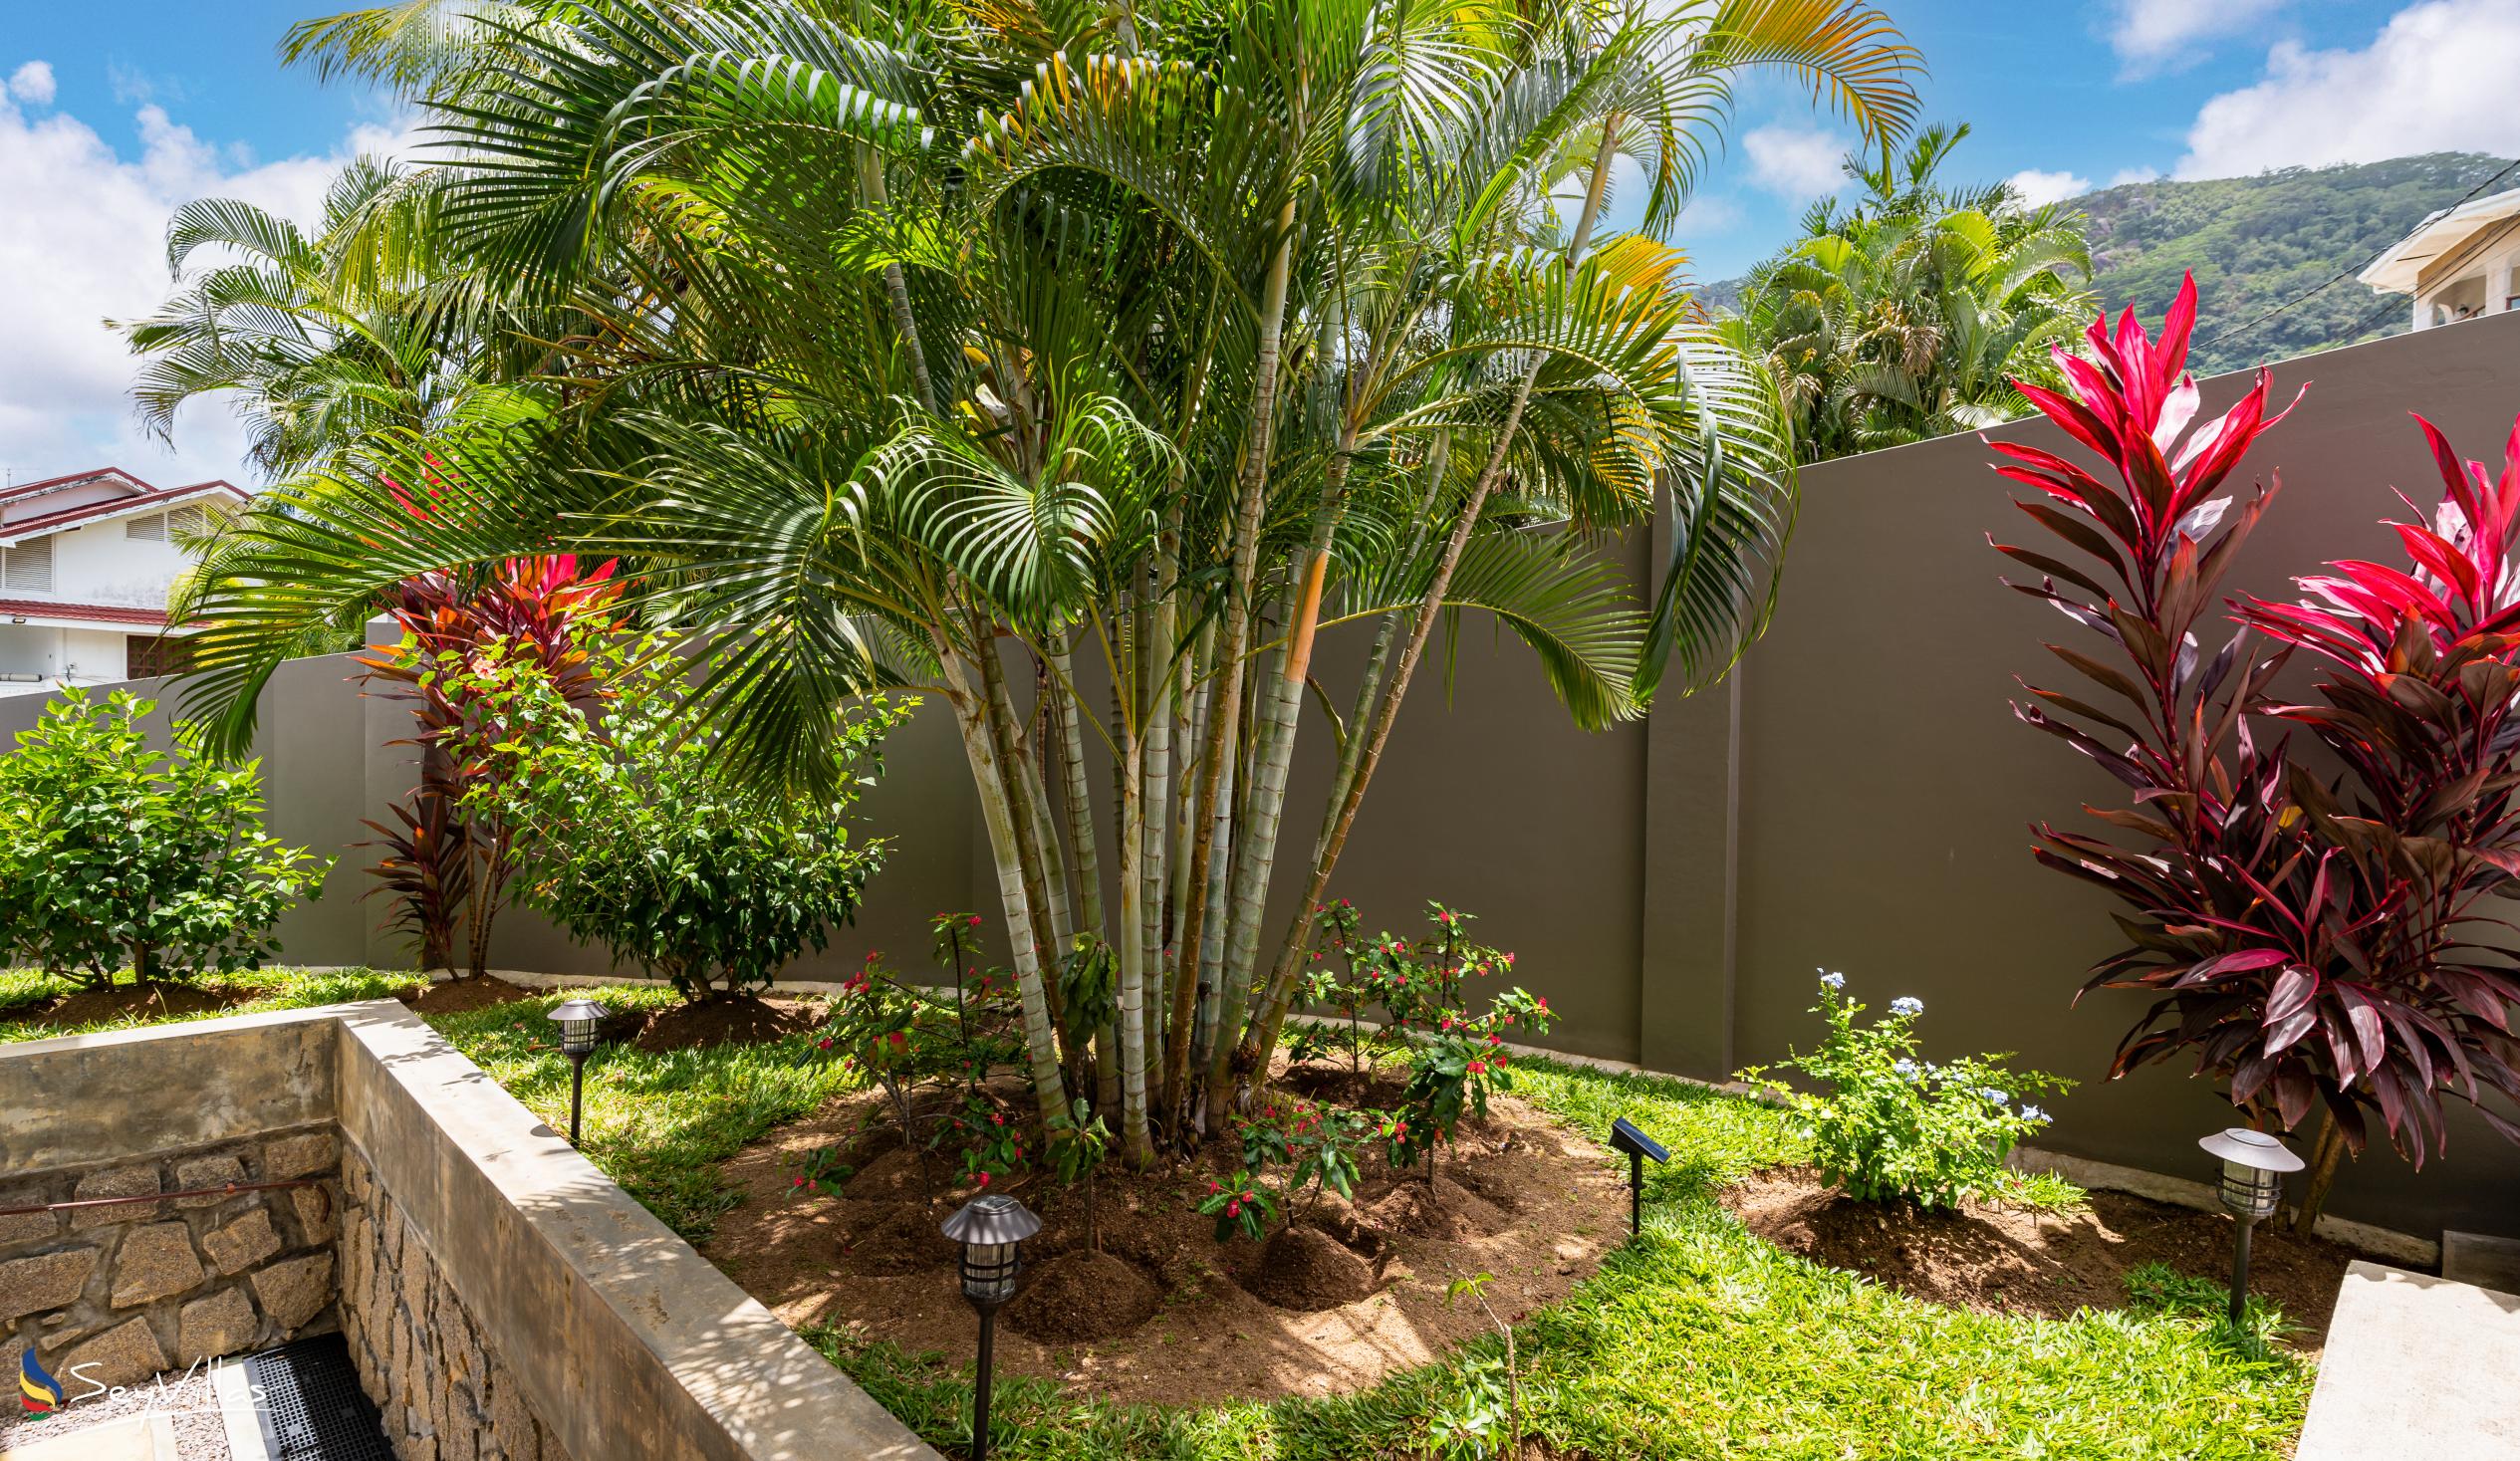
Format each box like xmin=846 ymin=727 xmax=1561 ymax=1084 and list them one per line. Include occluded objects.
xmin=361 ymin=554 xmax=620 ymax=977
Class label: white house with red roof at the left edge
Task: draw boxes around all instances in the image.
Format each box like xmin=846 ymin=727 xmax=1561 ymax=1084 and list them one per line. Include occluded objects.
xmin=0 ymin=466 xmax=247 ymax=695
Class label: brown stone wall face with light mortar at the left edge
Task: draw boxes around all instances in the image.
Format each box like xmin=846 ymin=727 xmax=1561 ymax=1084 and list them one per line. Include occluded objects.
xmin=0 ymin=1123 xmax=341 ymax=1398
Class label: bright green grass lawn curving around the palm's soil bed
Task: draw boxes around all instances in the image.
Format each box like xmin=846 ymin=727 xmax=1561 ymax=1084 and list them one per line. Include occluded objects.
xmin=0 ymin=975 xmax=2311 ymax=1461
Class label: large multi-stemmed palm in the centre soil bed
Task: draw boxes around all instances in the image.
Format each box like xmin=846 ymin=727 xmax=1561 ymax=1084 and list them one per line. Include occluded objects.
xmin=172 ymin=0 xmax=1912 ymax=1161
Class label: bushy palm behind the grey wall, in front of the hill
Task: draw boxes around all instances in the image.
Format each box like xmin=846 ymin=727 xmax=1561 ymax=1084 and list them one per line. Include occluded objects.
xmin=1731 ymin=125 xmax=2092 ymax=461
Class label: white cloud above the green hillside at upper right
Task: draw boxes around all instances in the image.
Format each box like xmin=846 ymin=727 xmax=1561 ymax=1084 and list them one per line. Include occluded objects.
xmin=2177 ymin=0 xmax=2520 ymax=179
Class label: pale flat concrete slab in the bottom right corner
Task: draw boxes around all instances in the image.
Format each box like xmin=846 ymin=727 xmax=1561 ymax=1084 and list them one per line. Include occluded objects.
xmin=2293 ymin=1262 xmax=2520 ymax=1461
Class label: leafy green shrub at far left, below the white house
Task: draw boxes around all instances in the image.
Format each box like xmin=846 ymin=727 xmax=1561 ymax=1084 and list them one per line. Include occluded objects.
xmin=0 ymin=690 xmax=328 ymax=982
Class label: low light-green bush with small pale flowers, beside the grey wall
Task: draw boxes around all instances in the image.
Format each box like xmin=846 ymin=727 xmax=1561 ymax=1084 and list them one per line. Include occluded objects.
xmin=1741 ymin=972 xmax=2074 ymax=1207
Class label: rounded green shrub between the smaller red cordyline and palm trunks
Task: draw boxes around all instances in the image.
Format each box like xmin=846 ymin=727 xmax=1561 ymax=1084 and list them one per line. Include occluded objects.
xmin=464 ymin=634 xmax=917 ymax=1000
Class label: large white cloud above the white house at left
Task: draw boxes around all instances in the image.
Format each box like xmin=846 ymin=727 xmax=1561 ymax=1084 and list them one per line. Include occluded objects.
xmin=0 ymin=88 xmax=410 ymax=484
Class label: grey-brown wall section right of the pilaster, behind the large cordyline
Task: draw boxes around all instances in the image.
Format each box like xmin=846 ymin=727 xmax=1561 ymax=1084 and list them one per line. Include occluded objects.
xmin=1693 ymin=318 xmax=2520 ymax=1232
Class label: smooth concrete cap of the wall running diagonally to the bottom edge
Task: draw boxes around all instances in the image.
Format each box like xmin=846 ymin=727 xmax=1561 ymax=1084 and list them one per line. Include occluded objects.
xmin=333 ymin=1000 xmax=935 ymax=1461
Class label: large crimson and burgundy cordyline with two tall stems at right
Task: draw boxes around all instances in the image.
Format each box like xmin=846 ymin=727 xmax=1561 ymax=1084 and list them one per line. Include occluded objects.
xmin=1988 ymin=280 xmax=2520 ymax=1227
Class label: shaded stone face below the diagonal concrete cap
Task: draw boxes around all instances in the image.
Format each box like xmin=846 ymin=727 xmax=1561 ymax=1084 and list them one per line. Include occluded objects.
xmin=341 ymin=1151 xmax=570 ymax=1461
